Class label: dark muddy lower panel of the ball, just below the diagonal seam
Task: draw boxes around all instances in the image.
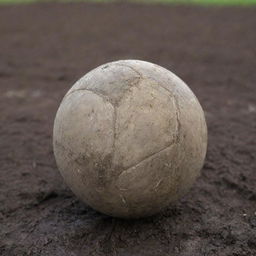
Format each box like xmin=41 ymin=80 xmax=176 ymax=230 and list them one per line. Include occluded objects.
xmin=116 ymin=144 xmax=181 ymax=217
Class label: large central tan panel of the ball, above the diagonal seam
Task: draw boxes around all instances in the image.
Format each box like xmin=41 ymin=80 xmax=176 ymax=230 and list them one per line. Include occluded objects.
xmin=114 ymin=79 xmax=178 ymax=168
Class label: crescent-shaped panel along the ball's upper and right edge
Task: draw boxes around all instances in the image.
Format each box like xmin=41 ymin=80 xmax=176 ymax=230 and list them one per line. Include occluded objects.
xmin=125 ymin=60 xmax=207 ymax=194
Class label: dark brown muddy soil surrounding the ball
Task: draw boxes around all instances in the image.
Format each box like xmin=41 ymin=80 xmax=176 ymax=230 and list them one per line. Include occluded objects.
xmin=0 ymin=3 xmax=256 ymax=256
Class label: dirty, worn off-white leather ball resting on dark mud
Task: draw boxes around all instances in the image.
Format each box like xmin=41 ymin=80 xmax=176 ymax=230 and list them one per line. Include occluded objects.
xmin=53 ymin=60 xmax=207 ymax=218
